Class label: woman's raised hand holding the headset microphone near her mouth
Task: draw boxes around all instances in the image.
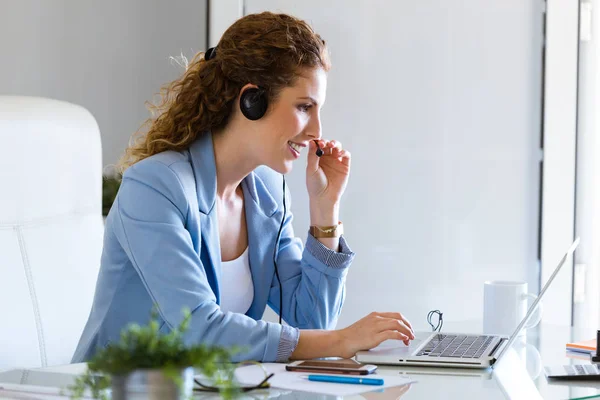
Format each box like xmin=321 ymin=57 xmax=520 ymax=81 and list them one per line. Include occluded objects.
xmin=306 ymin=140 xmax=350 ymax=209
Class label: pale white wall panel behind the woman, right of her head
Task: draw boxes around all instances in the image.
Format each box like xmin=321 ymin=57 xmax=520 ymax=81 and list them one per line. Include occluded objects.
xmin=211 ymin=0 xmax=543 ymax=328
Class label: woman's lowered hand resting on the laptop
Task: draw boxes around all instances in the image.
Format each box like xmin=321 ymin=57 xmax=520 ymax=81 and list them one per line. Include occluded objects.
xmin=336 ymin=312 xmax=415 ymax=358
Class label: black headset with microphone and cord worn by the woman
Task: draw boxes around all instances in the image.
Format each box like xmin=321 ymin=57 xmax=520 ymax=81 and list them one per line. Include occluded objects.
xmin=204 ymin=47 xmax=323 ymax=325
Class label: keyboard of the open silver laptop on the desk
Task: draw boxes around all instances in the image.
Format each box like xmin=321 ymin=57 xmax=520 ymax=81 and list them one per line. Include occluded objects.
xmin=417 ymin=334 xmax=494 ymax=358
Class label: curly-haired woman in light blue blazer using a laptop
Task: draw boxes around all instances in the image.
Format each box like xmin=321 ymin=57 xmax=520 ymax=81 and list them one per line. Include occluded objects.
xmin=73 ymin=13 xmax=414 ymax=362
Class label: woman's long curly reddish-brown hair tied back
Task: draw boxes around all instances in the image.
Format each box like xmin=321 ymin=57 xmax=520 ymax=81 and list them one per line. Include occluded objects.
xmin=117 ymin=12 xmax=331 ymax=174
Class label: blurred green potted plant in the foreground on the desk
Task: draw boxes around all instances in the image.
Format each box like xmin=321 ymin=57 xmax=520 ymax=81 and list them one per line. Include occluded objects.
xmin=68 ymin=310 xmax=237 ymax=400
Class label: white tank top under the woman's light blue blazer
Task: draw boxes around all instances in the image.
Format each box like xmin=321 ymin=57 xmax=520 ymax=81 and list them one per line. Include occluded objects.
xmin=220 ymin=247 xmax=254 ymax=314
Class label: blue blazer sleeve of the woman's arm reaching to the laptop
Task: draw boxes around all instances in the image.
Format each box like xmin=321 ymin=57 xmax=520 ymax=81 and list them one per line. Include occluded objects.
xmin=115 ymin=160 xmax=293 ymax=362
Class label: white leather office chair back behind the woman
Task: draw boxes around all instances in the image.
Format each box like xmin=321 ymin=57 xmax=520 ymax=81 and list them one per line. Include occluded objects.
xmin=0 ymin=96 xmax=103 ymax=369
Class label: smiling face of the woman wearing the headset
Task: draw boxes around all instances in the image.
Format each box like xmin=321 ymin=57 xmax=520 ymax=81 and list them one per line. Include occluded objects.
xmin=261 ymin=68 xmax=327 ymax=174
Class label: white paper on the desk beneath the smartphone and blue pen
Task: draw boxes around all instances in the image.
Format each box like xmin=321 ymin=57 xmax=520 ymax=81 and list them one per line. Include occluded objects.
xmin=226 ymin=363 xmax=416 ymax=396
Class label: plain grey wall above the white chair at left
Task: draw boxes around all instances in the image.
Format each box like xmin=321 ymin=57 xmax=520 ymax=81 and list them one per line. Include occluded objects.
xmin=0 ymin=0 xmax=207 ymax=170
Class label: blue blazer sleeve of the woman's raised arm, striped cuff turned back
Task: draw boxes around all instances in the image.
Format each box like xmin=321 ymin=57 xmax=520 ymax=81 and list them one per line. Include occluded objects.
xmin=269 ymin=188 xmax=354 ymax=329
